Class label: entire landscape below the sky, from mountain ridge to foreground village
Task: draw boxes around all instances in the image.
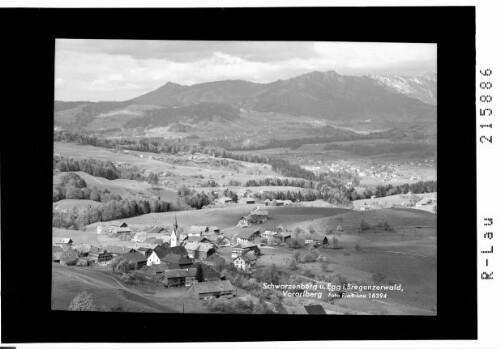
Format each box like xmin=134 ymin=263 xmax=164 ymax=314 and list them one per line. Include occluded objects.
xmin=52 ymin=39 xmax=437 ymax=316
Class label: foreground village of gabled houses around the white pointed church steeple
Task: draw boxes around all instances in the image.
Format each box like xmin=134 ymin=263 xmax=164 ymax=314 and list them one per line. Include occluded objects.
xmin=52 ymin=203 xmax=342 ymax=314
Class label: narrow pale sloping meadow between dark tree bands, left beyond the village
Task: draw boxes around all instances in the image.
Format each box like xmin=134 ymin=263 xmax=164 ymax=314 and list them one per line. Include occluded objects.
xmin=54 ymin=171 xmax=178 ymax=201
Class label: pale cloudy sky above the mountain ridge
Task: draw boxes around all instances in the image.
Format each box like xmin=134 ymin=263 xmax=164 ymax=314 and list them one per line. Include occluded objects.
xmin=54 ymin=39 xmax=437 ymax=101
